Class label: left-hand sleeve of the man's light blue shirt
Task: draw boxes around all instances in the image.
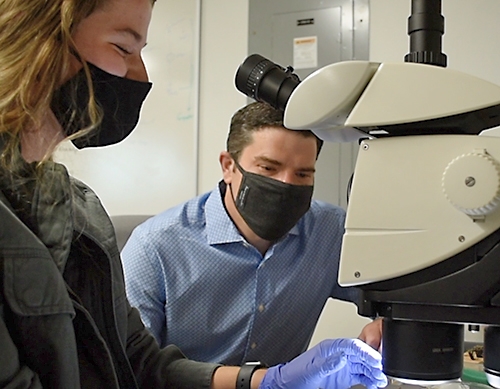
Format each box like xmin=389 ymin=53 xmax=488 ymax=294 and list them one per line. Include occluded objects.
xmin=121 ymin=226 xmax=166 ymax=347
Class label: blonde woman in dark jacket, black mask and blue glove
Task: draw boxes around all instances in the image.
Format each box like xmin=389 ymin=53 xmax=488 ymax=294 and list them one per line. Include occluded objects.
xmin=0 ymin=0 xmax=386 ymax=389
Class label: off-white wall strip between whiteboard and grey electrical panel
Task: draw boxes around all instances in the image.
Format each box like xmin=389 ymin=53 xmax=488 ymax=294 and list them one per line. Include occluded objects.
xmin=198 ymin=0 xmax=248 ymax=193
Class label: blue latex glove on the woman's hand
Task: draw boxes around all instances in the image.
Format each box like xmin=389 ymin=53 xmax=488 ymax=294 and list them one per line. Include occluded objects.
xmin=259 ymin=339 xmax=387 ymax=389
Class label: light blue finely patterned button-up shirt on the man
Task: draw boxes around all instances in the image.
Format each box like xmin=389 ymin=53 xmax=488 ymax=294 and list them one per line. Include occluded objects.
xmin=122 ymin=180 xmax=355 ymax=365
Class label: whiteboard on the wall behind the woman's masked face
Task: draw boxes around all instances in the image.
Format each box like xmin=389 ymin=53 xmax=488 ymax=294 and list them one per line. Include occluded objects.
xmin=54 ymin=0 xmax=201 ymax=216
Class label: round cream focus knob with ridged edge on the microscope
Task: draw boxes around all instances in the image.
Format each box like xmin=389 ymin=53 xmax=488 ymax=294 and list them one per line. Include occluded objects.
xmin=442 ymin=150 xmax=500 ymax=218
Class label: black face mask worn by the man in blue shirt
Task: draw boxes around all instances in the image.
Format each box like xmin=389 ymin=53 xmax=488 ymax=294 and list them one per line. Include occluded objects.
xmin=231 ymin=160 xmax=314 ymax=241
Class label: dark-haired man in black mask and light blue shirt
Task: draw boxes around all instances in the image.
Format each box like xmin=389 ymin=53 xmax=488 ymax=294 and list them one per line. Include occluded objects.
xmin=122 ymin=103 xmax=378 ymax=365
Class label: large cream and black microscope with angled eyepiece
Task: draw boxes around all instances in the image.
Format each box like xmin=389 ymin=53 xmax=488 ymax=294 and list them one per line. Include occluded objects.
xmin=235 ymin=0 xmax=500 ymax=388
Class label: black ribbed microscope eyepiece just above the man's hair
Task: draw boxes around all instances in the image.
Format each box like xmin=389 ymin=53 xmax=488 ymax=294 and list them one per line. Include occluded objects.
xmin=235 ymin=54 xmax=300 ymax=111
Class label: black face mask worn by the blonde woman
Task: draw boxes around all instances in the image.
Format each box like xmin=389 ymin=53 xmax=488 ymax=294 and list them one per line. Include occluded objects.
xmin=51 ymin=63 xmax=152 ymax=149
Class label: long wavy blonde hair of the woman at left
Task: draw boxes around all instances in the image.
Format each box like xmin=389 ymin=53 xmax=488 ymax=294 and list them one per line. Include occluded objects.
xmin=0 ymin=0 xmax=155 ymax=167
